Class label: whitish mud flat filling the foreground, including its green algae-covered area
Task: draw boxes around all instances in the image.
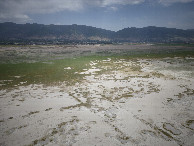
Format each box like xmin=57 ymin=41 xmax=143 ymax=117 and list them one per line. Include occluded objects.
xmin=0 ymin=45 xmax=194 ymax=146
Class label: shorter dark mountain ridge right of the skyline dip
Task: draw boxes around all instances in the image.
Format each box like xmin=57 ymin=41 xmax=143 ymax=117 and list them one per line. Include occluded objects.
xmin=114 ymin=26 xmax=194 ymax=42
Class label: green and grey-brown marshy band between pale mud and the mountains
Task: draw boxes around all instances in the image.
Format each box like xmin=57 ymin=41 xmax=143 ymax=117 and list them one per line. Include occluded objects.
xmin=0 ymin=45 xmax=194 ymax=89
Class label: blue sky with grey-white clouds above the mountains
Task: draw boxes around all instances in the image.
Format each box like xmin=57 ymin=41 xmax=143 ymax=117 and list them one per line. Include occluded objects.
xmin=0 ymin=0 xmax=194 ymax=31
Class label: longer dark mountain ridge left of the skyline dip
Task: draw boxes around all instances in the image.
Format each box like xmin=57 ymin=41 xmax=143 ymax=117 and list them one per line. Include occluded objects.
xmin=0 ymin=22 xmax=114 ymax=40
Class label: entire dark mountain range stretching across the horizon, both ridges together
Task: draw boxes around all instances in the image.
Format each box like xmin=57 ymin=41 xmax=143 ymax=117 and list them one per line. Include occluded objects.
xmin=0 ymin=22 xmax=194 ymax=43
